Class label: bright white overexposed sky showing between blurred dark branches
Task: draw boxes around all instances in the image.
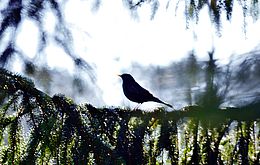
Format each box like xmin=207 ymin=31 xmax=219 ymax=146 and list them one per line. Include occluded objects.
xmin=13 ymin=0 xmax=260 ymax=105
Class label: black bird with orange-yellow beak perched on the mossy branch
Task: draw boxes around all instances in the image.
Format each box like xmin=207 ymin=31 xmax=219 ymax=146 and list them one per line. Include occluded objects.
xmin=119 ymin=73 xmax=173 ymax=108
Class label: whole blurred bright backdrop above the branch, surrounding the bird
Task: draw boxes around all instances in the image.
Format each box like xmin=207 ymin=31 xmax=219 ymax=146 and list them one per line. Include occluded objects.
xmin=0 ymin=0 xmax=260 ymax=109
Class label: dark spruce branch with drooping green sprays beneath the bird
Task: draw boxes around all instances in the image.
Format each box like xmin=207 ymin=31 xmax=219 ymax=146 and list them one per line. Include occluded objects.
xmin=0 ymin=69 xmax=260 ymax=164
